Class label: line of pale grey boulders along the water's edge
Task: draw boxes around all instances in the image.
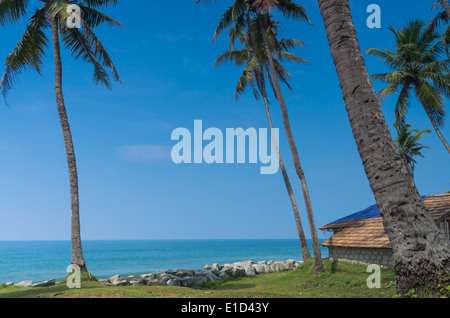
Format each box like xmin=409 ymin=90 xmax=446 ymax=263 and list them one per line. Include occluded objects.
xmin=5 ymin=260 xmax=302 ymax=287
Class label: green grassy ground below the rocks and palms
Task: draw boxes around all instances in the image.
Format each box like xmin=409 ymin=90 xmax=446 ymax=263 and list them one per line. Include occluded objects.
xmin=0 ymin=260 xmax=395 ymax=298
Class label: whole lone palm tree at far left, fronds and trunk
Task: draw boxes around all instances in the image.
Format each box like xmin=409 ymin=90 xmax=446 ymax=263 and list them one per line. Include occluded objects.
xmin=0 ymin=0 xmax=120 ymax=272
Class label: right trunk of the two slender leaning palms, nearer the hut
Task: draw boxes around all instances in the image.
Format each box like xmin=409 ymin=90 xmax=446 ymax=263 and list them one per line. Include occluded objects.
xmin=258 ymin=13 xmax=323 ymax=274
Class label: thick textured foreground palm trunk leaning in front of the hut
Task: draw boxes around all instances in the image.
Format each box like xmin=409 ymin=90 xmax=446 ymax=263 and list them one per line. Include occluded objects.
xmin=318 ymin=0 xmax=450 ymax=294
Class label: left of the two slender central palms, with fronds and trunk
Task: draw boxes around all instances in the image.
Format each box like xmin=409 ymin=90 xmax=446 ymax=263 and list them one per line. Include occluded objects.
xmin=215 ymin=18 xmax=311 ymax=261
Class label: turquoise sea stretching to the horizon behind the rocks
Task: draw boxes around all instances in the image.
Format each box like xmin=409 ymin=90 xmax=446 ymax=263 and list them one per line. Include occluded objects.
xmin=0 ymin=239 xmax=328 ymax=284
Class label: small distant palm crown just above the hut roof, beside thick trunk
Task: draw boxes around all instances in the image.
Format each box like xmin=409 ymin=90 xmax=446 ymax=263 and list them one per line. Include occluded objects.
xmin=394 ymin=123 xmax=431 ymax=178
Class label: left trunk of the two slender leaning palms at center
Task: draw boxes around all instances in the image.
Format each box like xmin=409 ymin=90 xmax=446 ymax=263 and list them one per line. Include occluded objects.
xmin=260 ymin=67 xmax=311 ymax=261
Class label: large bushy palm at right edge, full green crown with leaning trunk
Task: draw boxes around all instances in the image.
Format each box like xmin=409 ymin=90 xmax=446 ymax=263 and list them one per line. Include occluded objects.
xmin=367 ymin=20 xmax=450 ymax=154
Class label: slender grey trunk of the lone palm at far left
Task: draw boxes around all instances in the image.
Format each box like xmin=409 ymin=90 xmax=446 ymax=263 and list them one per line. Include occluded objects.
xmin=52 ymin=17 xmax=87 ymax=272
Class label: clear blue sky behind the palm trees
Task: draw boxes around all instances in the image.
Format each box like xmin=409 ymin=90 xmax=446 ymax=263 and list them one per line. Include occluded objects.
xmin=0 ymin=0 xmax=450 ymax=240
